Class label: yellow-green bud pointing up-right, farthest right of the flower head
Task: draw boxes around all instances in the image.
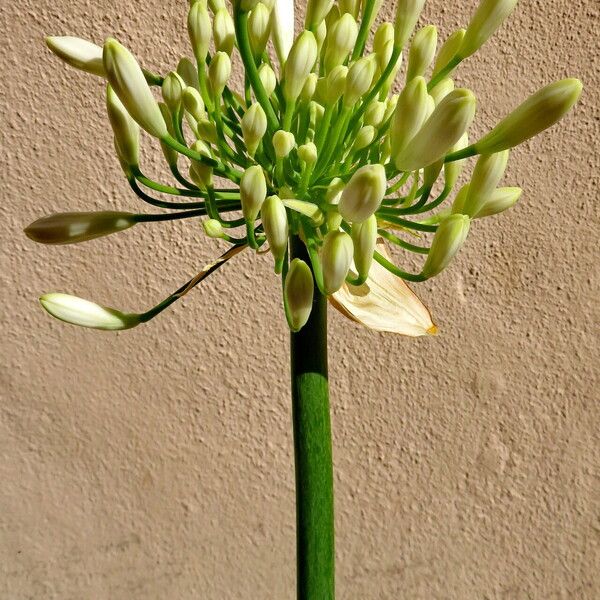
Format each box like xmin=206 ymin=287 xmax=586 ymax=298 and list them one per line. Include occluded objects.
xmin=475 ymin=79 xmax=583 ymax=154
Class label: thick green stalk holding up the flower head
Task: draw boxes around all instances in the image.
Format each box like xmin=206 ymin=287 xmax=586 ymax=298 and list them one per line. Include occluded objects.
xmin=291 ymin=237 xmax=335 ymax=600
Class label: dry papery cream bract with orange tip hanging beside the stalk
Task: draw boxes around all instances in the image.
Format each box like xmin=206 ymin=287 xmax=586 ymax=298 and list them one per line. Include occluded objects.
xmin=329 ymin=238 xmax=437 ymax=337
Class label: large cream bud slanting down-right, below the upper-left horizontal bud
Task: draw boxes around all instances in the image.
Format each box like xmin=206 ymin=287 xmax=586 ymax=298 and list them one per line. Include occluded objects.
xmin=103 ymin=38 xmax=168 ymax=139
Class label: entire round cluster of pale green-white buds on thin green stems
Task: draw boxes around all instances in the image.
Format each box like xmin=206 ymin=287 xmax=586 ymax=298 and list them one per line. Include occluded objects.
xmin=26 ymin=0 xmax=582 ymax=335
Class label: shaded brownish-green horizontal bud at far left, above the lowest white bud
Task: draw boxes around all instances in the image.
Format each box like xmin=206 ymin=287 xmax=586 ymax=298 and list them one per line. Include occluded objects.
xmin=25 ymin=211 xmax=137 ymax=244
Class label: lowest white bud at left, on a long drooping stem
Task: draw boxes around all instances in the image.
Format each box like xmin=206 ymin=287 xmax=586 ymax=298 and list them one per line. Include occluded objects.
xmin=40 ymin=293 xmax=141 ymax=331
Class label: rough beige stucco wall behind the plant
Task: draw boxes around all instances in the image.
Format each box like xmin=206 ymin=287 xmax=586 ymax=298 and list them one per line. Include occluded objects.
xmin=0 ymin=0 xmax=600 ymax=600
